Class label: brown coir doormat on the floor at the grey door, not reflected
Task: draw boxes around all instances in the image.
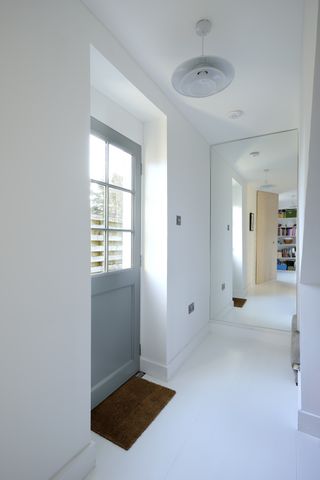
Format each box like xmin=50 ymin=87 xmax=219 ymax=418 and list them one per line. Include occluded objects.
xmin=91 ymin=377 xmax=176 ymax=450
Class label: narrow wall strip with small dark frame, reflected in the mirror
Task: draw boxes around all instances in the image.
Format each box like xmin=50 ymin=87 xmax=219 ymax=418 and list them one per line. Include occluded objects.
xmin=245 ymin=184 xmax=257 ymax=289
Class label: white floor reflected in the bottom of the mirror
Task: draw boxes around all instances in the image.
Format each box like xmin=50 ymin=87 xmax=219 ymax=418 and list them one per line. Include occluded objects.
xmin=224 ymin=272 xmax=296 ymax=331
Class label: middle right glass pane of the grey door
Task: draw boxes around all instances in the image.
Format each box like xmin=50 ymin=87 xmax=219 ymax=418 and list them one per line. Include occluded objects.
xmin=108 ymin=188 xmax=132 ymax=230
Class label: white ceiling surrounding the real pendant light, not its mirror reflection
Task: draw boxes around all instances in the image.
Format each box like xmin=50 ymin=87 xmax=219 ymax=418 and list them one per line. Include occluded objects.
xmin=84 ymin=0 xmax=303 ymax=144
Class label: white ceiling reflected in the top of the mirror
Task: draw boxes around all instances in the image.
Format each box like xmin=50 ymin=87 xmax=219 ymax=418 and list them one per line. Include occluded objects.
xmin=213 ymin=130 xmax=298 ymax=194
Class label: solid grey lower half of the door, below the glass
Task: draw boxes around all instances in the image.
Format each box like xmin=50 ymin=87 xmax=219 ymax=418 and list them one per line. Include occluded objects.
xmin=91 ymin=269 xmax=140 ymax=408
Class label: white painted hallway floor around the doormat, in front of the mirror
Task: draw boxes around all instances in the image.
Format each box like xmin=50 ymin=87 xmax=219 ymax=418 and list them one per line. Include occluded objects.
xmin=88 ymin=282 xmax=298 ymax=480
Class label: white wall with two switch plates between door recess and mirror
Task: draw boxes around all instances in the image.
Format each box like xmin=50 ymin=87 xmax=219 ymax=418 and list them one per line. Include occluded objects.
xmin=167 ymin=114 xmax=210 ymax=375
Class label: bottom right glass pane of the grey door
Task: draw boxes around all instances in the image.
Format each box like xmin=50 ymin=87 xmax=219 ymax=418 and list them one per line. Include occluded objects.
xmin=108 ymin=231 xmax=132 ymax=272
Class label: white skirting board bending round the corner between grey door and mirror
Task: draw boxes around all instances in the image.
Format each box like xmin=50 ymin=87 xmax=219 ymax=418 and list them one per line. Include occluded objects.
xmin=140 ymin=324 xmax=210 ymax=382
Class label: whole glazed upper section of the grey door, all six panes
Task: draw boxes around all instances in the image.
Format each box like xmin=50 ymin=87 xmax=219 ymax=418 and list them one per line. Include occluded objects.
xmin=90 ymin=122 xmax=135 ymax=274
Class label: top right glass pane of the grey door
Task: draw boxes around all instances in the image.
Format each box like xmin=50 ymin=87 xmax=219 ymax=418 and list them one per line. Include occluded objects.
xmin=109 ymin=144 xmax=132 ymax=190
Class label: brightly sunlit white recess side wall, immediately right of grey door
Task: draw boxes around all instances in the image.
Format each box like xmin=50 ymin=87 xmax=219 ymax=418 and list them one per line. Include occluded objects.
xmin=141 ymin=118 xmax=168 ymax=377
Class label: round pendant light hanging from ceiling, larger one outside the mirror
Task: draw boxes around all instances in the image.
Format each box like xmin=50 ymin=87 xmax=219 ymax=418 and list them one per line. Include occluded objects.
xmin=172 ymin=19 xmax=234 ymax=98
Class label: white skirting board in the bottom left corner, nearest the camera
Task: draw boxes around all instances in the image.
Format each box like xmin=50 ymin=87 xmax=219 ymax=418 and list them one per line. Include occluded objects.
xmin=50 ymin=442 xmax=96 ymax=480
